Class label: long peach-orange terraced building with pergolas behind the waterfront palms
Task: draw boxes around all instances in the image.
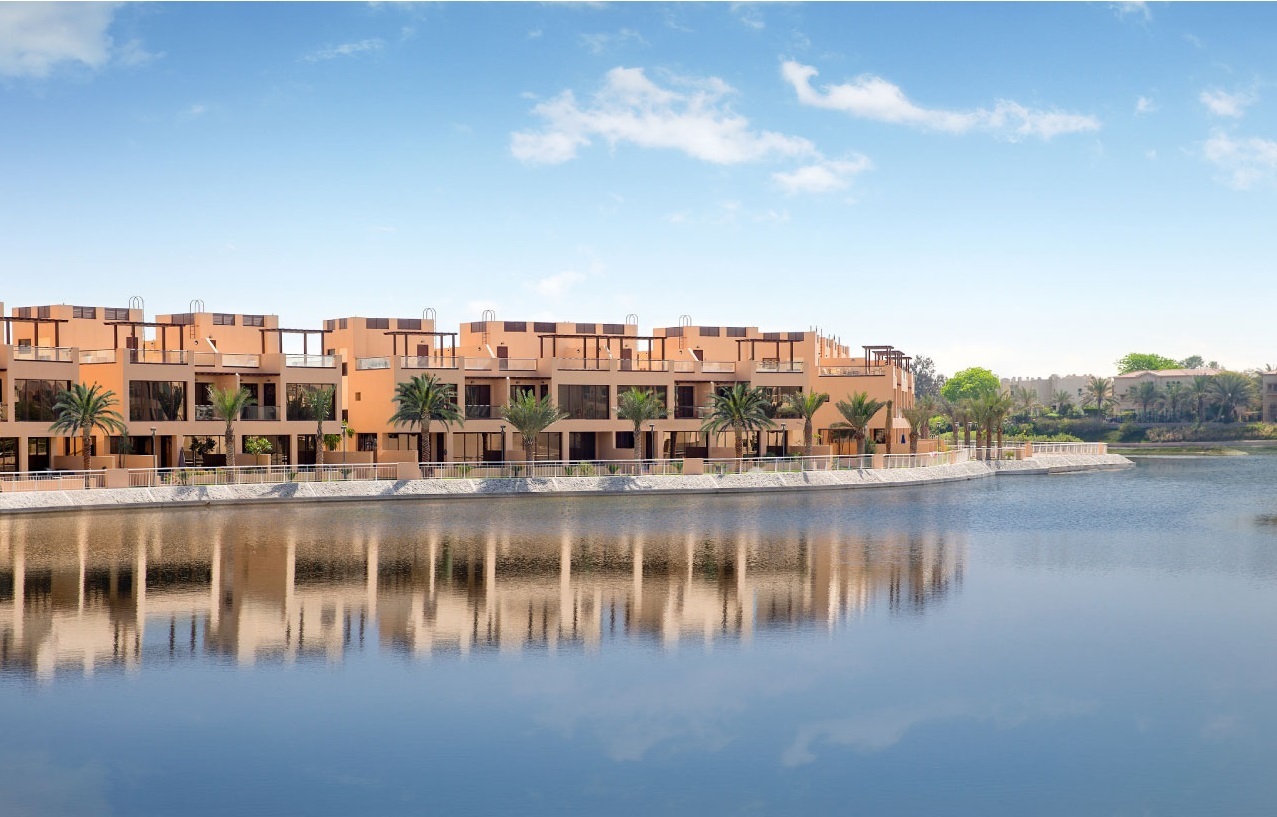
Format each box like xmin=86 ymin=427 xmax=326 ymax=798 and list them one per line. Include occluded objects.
xmin=0 ymin=303 xmax=926 ymax=471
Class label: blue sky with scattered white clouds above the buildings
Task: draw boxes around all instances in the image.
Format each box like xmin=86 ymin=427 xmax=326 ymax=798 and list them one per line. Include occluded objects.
xmin=0 ymin=3 xmax=1277 ymax=377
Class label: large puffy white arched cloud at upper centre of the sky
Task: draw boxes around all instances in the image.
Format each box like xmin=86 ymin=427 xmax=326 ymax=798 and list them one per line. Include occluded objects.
xmin=511 ymin=68 xmax=816 ymax=165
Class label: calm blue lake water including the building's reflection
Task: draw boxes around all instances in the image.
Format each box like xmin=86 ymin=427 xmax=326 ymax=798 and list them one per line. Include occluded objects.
xmin=0 ymin=456 xmax=1277 ymax=816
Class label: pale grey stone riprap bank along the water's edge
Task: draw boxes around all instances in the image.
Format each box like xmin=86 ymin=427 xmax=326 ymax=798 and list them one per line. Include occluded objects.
xmin=0 ymin=454 xmax=1133 ymax=513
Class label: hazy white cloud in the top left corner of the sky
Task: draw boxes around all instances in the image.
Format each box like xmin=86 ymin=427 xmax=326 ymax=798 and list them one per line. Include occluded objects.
xmin=0 ymin=3 xmax=151 ymax=79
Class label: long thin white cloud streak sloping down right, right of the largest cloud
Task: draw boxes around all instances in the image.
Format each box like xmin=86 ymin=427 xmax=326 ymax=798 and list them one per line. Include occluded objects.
xmin=780 ymin=60 xmax=1099 ymax=139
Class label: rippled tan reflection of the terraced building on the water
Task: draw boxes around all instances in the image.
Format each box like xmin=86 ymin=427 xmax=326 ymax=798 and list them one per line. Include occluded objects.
xmin=0 ymin=509 xmax=964 ymax=678
